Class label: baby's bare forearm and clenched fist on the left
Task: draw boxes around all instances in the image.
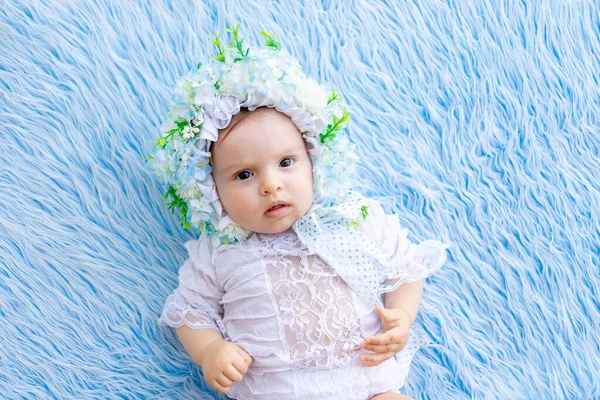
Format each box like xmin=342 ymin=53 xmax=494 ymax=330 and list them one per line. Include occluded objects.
xmin=176 ymin=325 xmax=253 ymax=393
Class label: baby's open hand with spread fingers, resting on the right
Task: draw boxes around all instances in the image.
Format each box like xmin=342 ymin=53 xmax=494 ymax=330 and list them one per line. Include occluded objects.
xmin=359 ymin=306 xmax=411 ymax=367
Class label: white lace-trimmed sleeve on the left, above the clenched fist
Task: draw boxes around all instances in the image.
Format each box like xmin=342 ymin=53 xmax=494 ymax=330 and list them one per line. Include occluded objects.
xmin=158 ymin=238 xmax=226 ymax=337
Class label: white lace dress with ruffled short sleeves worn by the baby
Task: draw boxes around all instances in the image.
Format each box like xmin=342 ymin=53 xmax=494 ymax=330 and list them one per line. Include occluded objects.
xmin=159 ymin=200 xmax=446 ymax=400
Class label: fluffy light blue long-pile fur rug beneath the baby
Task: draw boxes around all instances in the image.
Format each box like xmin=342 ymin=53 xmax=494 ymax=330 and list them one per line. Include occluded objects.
xmin=0 ymin=0 xmax=600 ymax=399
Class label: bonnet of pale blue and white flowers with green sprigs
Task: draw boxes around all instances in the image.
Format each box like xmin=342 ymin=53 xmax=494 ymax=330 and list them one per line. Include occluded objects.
xmin=145 ymin=24 xmax=356 ymax=244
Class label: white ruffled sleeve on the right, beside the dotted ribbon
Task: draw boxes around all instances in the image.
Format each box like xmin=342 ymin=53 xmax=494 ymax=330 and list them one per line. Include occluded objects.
xmin=361 ymin=199 xmax=450 ymax=292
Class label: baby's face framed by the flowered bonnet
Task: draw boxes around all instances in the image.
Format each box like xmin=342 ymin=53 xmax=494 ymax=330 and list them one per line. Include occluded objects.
xmin=211 ymin=107 xmax=313 ymax=233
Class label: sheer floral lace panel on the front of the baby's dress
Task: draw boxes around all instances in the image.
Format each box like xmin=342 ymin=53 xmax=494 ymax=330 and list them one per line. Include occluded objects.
xmin=267 ymin=250 xmax=363 ymax=368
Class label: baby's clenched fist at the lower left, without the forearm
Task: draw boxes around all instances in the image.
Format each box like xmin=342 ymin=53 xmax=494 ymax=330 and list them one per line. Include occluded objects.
xmin=200 ymin=340 xmax=253 ymax=393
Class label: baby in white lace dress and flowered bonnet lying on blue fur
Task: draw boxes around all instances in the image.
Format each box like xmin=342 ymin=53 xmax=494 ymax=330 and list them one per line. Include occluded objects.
xmin=149 ymin=27 xmax=449 ymax=400
